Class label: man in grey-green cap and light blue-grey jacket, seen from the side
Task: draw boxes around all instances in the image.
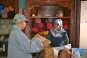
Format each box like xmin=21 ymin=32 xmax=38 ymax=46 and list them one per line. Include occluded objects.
xmin=8 ymin=14 xmax=43 ymax=58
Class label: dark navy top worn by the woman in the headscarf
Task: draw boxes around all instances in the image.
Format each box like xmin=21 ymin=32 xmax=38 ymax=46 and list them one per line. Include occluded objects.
xmin=47 ymin=31 xmax=69 ymax=47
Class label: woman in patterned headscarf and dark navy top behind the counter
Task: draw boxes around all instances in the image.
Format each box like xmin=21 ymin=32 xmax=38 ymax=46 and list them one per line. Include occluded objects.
xmin=47 ymin=19 xmax=69 ymax=47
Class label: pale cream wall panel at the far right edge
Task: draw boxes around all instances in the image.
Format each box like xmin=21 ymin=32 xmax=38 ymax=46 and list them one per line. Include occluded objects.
xmin=80 ymin=1 xmax=87 ymax=49
